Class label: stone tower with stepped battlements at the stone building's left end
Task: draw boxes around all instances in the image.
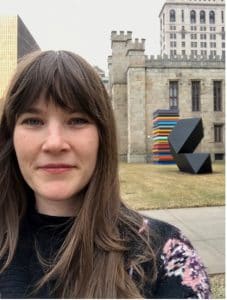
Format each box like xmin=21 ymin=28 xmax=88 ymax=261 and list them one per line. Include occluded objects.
xmin=108 ymin=31 xmax=146 ymax=162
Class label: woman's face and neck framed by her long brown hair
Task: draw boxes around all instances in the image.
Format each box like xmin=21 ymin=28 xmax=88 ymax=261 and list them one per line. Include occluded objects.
xmin=13 ymin=97 xmax=99 ymax=215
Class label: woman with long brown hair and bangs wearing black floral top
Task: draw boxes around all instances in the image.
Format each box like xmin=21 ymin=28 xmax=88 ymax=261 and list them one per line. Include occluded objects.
xmin=0 ymin=51 xmax=209 ymax=298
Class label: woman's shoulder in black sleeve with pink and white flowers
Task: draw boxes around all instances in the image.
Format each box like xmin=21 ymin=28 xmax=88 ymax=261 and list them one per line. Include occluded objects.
xmin=141 ymin=218 xmax=210 ymax=298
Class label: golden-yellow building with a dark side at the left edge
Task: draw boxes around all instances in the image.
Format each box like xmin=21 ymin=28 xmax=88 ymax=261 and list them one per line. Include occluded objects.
xmin=0 ymin=15 xmax=40 ymax=98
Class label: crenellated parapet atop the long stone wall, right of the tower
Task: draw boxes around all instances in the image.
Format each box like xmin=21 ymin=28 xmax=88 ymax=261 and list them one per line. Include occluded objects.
xmin=145 ymin=55 xmax=225 ymax=69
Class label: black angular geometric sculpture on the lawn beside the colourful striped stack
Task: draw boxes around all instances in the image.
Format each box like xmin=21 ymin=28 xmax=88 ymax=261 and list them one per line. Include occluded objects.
xmin=168 ymin=118 xmax=212 ymax=174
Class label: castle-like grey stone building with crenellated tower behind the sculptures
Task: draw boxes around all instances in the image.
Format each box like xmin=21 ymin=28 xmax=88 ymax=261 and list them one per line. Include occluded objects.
xmin=108 ymin=31 xmax=225 ymax=162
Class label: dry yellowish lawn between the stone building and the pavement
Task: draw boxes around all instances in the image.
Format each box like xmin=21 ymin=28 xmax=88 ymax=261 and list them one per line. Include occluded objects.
xmin=119 ymin=163 xmax=225 ymax=210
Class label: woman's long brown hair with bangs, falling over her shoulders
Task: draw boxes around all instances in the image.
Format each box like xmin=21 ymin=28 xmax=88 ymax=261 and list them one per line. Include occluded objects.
xmin=0 ymin=51 xmax=156 ymax=298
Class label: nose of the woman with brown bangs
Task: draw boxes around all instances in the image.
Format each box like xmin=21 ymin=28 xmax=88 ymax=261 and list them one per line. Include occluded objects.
xmin=42 ymin=124 xmax=70 ymax=153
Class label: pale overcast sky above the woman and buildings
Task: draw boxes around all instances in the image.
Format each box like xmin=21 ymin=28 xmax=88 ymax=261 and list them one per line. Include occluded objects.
xmin=0 ymin=0 xmax=165 ymax=71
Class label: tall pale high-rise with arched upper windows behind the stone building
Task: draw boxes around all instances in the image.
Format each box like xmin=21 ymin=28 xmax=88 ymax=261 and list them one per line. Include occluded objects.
xmin=159 ymin=0 xmax=225 ymax=56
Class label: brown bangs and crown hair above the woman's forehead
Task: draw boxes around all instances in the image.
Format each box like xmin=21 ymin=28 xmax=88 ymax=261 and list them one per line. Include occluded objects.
xmin=11 ymin=51 xmax=103 ymax=122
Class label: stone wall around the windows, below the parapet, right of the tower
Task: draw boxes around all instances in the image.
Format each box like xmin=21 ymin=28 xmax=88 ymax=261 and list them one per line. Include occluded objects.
xmin=146 ymin=66 xmax=225 ymax=161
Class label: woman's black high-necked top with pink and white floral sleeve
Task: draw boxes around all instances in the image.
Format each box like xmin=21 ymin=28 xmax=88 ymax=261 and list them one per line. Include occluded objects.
xmin=0 ymin=207 xmax=210 ymax=299
